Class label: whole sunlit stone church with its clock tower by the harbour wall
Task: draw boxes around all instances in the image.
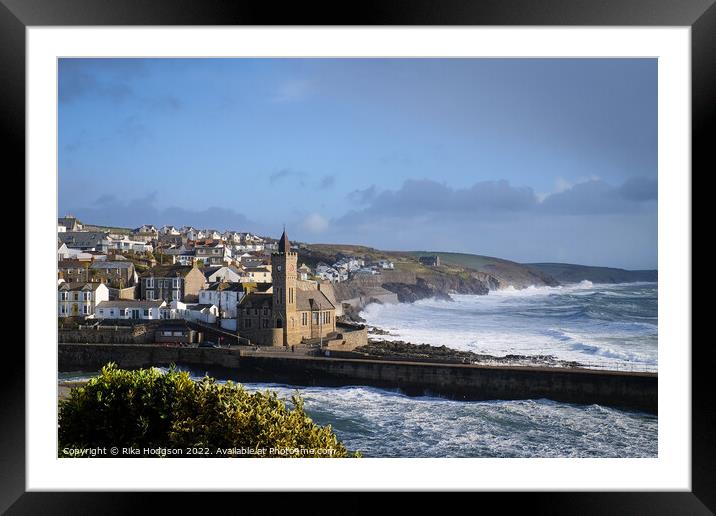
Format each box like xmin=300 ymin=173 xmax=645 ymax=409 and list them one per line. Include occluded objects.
xmin=237 ymin=230 xmax=336 ymax=346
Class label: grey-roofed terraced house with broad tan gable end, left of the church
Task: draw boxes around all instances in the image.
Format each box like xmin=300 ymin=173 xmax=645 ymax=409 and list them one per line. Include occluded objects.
xmin=140 ymin=265 xmax=205 ymax=303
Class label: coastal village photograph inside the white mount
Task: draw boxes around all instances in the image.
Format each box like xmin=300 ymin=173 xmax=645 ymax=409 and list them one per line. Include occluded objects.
xmin=57 ymin=57 xmax=660 ymax=462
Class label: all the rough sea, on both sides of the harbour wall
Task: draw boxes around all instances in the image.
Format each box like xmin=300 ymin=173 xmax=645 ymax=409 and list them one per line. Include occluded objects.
xmin=61 ymin=282 xmax=658 ymax=458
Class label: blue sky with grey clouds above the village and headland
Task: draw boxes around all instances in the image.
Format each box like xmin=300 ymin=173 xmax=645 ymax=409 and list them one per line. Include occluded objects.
xmin=59 ymin=59 xmax=657 ymax=268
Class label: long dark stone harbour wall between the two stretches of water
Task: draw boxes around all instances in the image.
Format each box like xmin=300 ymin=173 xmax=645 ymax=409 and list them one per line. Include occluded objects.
xmin=59 ymin=344 xmax=658 ymax=414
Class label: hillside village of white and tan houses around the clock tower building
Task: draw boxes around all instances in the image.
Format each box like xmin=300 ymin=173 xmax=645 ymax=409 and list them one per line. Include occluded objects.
xmin=57 ymin=215 xmax=402 ymax=346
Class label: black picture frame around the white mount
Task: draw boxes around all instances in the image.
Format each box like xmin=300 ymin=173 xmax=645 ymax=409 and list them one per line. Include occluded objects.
xmin=0 ymin=0 xmax=716 ymax=514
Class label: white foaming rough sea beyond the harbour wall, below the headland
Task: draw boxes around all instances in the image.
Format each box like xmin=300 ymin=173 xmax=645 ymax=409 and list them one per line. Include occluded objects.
xmin=361 ymin=282 xmax=658 ymax=370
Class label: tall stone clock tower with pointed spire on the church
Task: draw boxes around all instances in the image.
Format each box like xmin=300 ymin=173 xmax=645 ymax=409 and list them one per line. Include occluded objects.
xmin=271 ymin=229 xmax=301 ymax=346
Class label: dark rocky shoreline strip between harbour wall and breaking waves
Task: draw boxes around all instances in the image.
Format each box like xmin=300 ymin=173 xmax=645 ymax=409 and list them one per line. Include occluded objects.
xmin=355 ymin=327 xmax=583 ymax=368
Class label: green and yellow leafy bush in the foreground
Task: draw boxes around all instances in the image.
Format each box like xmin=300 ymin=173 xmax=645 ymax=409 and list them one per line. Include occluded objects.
xmin=59 ymin=363 xmax=359 ymax=458
